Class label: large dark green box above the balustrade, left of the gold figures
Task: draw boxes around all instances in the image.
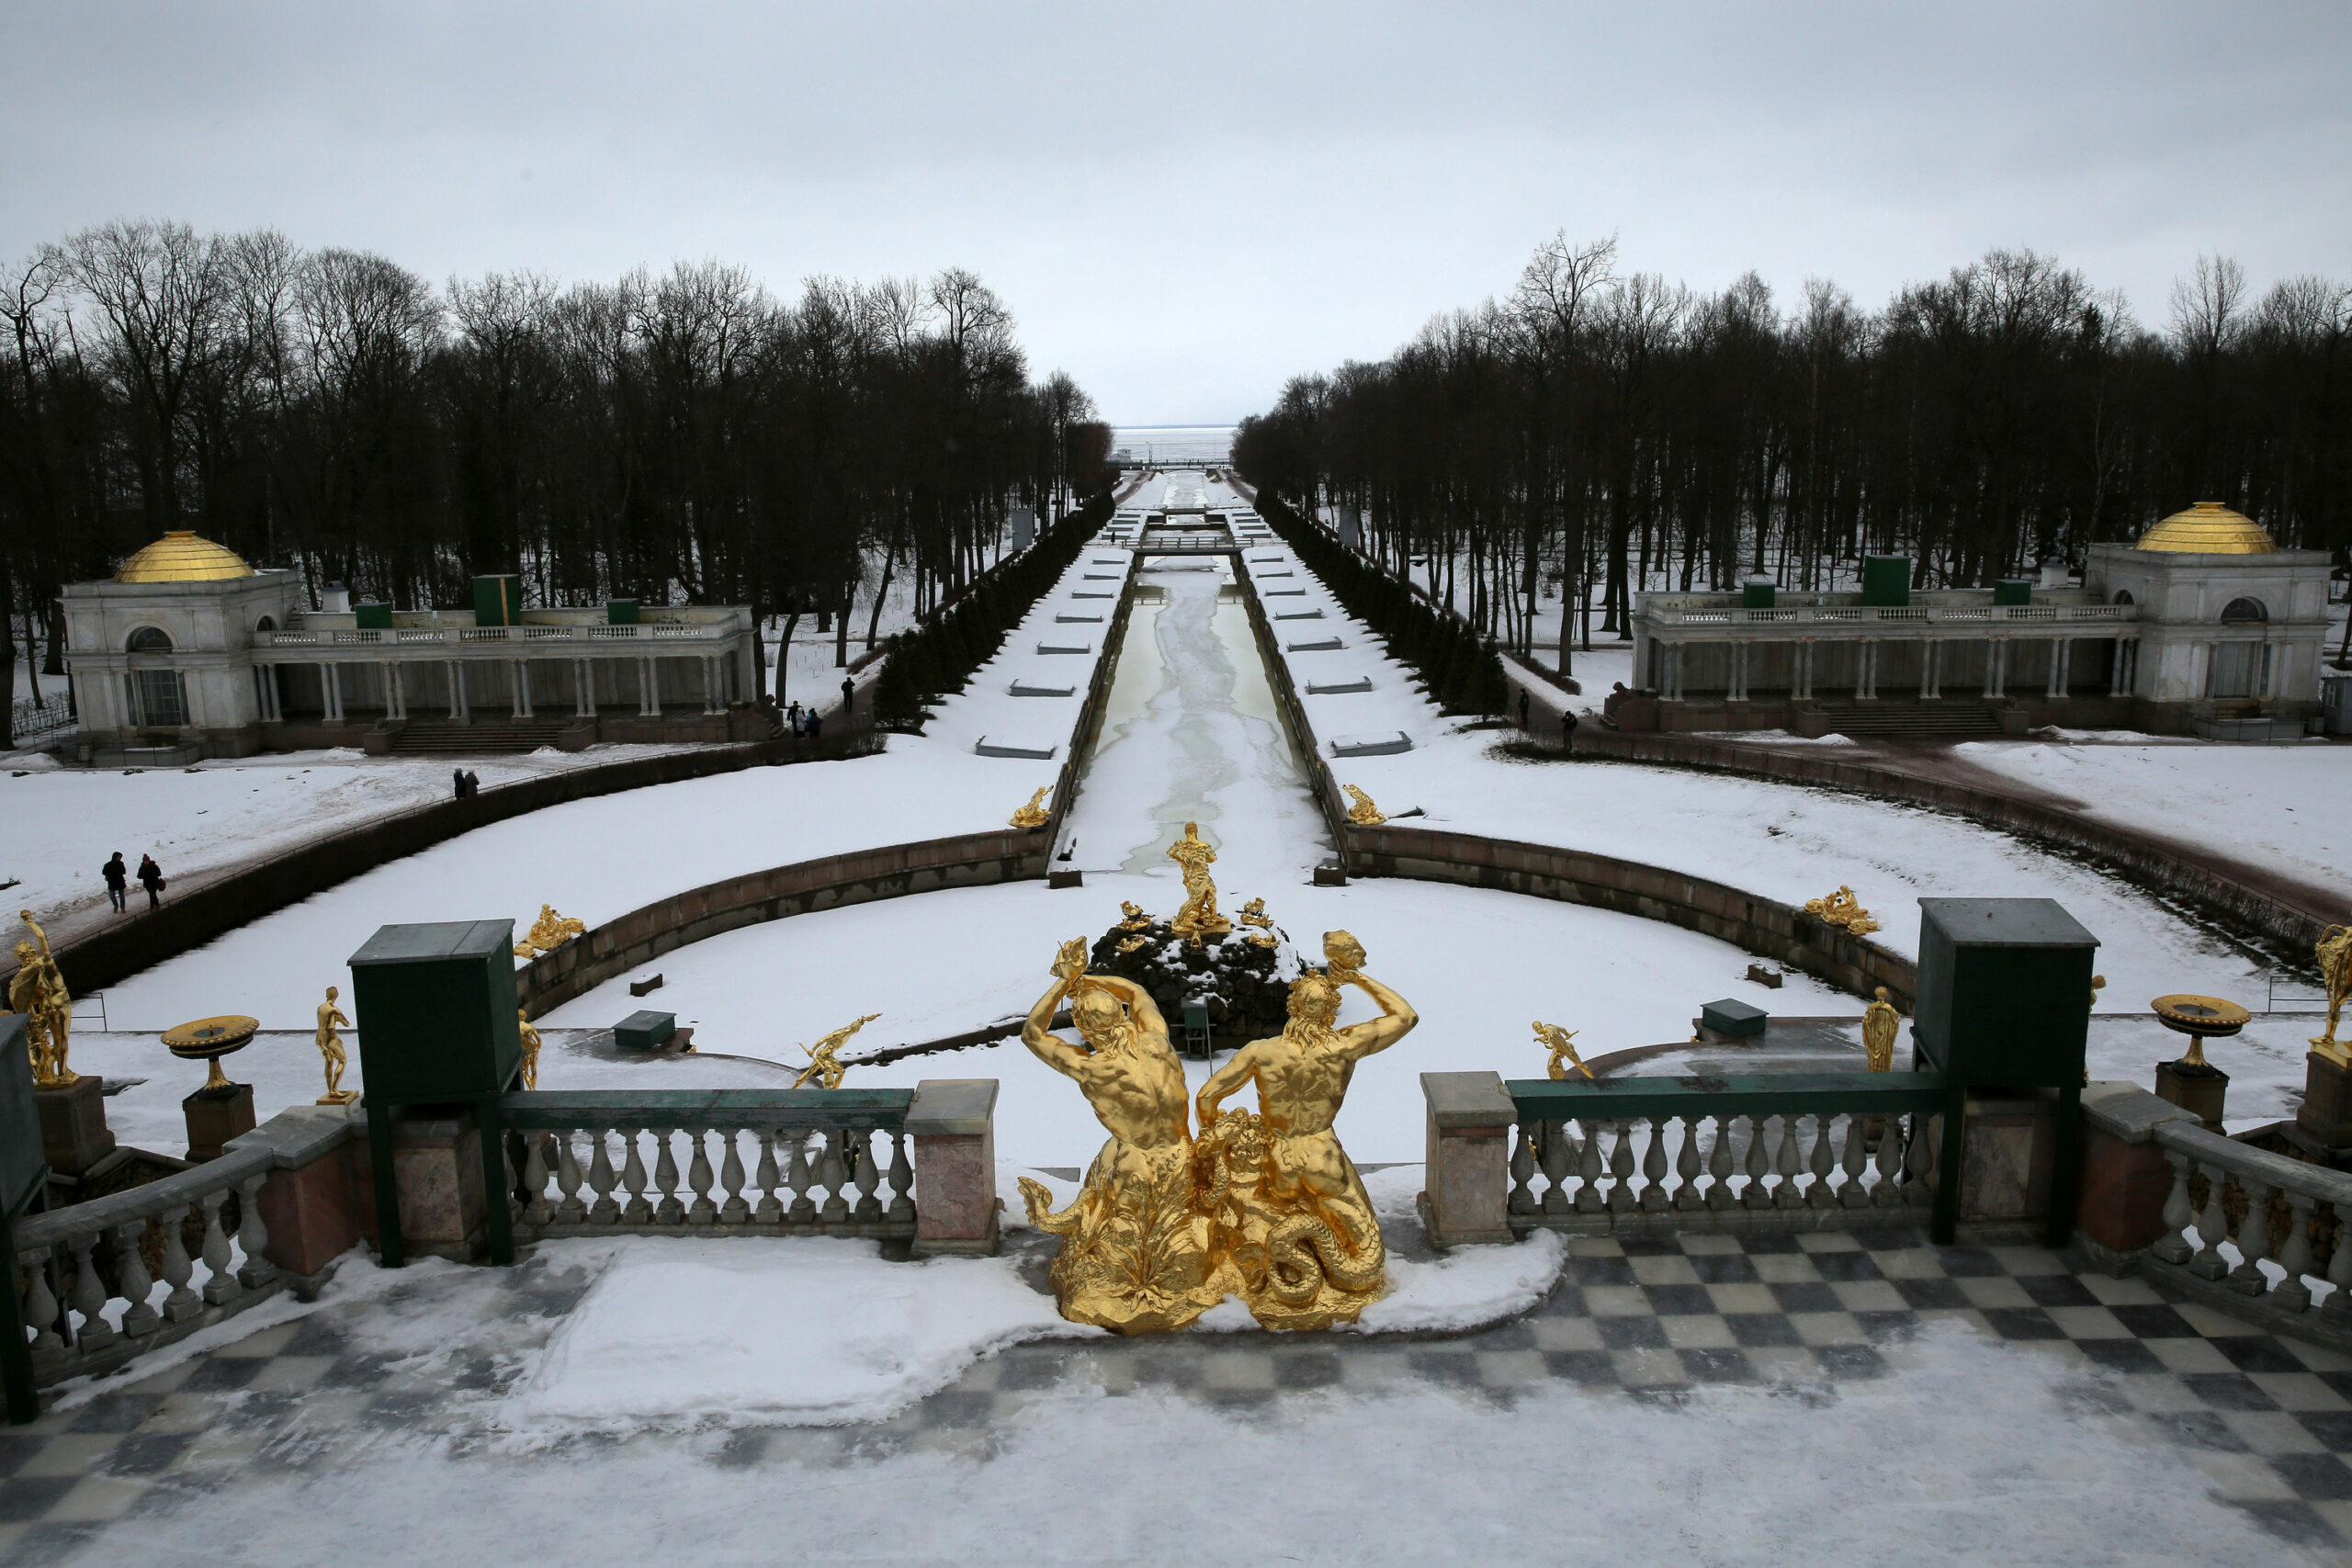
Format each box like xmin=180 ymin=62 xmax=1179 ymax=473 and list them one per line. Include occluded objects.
xmin=350 ymin=919 xmax=522 ymax=1102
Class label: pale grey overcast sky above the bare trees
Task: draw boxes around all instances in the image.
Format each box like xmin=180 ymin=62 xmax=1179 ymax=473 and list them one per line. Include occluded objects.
xmin=0 ymin=0 xmax=2352 ymax=423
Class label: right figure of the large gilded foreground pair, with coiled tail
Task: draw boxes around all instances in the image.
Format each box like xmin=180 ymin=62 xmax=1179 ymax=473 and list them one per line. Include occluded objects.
xmin=1194 ymin=931 xmax=1420 ymax=1328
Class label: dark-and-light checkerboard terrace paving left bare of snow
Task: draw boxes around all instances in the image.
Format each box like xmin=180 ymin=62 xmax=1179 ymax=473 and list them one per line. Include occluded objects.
xmin=14 ymin=1229 xmax=2352 ymax=1563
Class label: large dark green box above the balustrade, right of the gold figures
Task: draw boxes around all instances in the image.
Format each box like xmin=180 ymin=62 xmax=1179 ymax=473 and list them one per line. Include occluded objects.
xmin=1912 ymin=898 xmax=2098 ymax=1089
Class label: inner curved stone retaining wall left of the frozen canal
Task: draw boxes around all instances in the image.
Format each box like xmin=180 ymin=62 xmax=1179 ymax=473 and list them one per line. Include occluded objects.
xmin=529 ymin=828 xmax=1051 ymax=1013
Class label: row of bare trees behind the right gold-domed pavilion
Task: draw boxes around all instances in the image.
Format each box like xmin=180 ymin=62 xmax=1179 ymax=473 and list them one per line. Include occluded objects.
xmin=1232 ymin=235 xmax=2352 ymax=649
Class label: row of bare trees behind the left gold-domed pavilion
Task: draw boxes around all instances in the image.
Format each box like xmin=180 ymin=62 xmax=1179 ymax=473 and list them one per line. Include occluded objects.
xmin=0 ymin=221 xmax=1110 ymax=742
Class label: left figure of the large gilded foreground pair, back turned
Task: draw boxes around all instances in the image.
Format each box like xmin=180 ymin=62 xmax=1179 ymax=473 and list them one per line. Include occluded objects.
xmin=1021 ymin=938 xmax=1226 ymax=1333
